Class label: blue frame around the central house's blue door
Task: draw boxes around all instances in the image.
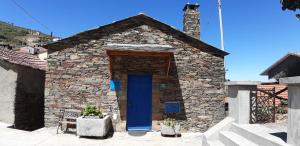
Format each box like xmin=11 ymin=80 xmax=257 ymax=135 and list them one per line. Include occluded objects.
xmin=126 ymin=73 xmax=153 ymax=131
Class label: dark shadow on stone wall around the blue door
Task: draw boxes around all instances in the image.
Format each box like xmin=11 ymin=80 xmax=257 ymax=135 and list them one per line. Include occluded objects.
xmin=111 ymin=55 xmax=187 ymax=121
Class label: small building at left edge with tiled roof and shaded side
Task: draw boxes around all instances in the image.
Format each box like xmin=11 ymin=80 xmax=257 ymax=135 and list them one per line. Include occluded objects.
xmin=0 ymin=48 xmax=46 ymax=130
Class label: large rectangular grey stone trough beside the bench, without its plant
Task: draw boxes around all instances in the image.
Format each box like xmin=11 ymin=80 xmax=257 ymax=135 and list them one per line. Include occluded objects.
xmin=76 ymin=116 xmax=112 ymax=137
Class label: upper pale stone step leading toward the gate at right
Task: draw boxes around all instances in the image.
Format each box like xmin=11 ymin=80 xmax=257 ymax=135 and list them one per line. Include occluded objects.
xmin=230 ymin=123 xmax=289 ymax=146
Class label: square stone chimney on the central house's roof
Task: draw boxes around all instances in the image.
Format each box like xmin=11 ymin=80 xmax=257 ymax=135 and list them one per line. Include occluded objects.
xmin=183 ymin=3 xmax=200 ymax=39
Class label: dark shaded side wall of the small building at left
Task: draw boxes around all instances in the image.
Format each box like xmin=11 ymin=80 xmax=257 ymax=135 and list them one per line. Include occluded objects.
xmin=14 ymin=66 xmax=45 ymax=131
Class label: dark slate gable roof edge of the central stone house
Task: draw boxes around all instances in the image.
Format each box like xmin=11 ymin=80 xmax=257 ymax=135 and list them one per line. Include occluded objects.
xmin=43 ymin=14 xmax=229 ymax=56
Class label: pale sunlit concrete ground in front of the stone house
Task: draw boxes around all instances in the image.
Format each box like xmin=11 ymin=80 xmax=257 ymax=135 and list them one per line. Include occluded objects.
xmin=0 ymin=123 xmax=202 ymax=146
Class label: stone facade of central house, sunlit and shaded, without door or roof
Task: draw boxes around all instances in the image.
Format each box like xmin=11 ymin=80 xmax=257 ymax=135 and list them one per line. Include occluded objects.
xmin=45 ymin=24 xmax=225 ymax=132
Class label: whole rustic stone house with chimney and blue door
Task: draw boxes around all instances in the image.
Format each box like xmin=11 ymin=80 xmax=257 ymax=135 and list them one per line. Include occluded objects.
xmin=44 ymin=4 xmax=228 ymax=131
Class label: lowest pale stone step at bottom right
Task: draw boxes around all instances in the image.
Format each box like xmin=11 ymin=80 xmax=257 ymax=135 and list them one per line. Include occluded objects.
xmin=220 ymin=131 xmax=258 ymax=146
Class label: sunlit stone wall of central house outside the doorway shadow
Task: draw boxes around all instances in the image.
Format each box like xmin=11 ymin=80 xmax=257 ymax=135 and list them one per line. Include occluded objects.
xmin=45 ymin=25 xmax=225 ymax=132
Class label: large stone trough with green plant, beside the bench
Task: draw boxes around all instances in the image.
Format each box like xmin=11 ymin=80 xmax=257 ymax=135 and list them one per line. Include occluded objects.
xmin=76 ymin=105 xmax=111 ymax=137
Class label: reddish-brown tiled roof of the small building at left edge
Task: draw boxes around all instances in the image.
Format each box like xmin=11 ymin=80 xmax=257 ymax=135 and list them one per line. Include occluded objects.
xmin=0 ymin=47 xmax=47 ymax=71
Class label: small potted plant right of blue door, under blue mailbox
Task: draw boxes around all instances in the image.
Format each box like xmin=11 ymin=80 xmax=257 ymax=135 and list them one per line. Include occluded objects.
xmin=160 ymin=118 xmax=180 ymax=136
